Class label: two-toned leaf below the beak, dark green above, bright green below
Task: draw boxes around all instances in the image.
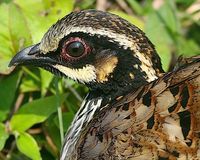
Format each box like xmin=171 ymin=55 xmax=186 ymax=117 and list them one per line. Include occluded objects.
xmin=10 ymin=95 xmax=66 ymax=132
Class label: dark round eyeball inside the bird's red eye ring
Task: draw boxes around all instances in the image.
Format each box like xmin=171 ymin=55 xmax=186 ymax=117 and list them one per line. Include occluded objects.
xmin=67 ymin=42 xmax=85 ymax=57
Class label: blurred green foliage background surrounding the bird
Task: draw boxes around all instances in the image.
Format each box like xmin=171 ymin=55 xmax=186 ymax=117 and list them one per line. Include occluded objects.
xmin=0 ymin=0 xmax=200 ymax=160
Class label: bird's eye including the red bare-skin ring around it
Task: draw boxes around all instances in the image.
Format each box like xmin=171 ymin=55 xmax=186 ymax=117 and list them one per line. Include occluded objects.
xmin=61 ymin=37 xmax=90 ymax=60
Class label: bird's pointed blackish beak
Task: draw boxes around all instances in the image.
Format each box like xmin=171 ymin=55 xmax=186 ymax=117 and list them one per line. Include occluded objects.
xmin=8 ymin=43 xmax=55 ymax=67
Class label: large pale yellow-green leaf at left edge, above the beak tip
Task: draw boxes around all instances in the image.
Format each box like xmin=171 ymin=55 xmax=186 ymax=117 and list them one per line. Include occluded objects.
xmin=0 ymin=3 xmax=31 ymax=74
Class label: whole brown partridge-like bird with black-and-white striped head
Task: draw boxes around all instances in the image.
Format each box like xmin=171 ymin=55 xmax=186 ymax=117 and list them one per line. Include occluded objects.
xmin=10 ymin=10 xmax=200 ymax=160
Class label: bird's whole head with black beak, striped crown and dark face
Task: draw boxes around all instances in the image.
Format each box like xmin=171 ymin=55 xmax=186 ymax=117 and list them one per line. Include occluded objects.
xmin=10 ymin=10 xmax=163 ymax=95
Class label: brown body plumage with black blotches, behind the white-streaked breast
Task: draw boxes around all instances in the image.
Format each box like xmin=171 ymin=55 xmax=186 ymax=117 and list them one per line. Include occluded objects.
xmin=78 ymin=58 xmax=200 ymax=159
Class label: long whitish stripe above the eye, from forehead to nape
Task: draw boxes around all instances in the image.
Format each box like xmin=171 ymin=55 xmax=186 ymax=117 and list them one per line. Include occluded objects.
xmin=40 ymin=26 xmax=158 ymax=82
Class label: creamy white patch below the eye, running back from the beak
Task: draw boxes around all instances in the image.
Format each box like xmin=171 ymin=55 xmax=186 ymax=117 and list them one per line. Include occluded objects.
xmin=53 ymin=64 xmax=96 ymax=84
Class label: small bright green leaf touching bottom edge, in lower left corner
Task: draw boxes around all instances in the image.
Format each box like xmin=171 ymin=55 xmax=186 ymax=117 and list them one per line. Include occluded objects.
xmin=16 ymin=132 xmax=42 ymax=160
